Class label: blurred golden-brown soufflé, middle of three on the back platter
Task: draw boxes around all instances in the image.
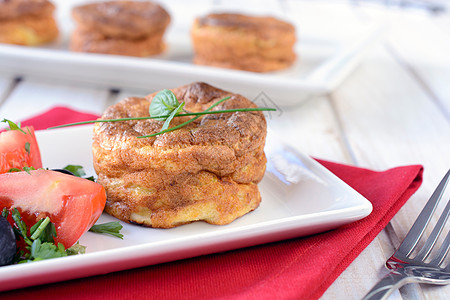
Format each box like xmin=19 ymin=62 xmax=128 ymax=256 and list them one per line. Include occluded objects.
xmin=70 ymin=1 xmax=170 ymax=57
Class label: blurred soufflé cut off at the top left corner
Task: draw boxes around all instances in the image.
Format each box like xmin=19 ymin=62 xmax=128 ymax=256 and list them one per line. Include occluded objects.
xmin=0 ymin=0 xmax=59 ymax=46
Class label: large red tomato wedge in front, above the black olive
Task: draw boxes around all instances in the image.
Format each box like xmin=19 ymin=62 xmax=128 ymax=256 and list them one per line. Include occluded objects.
xmin=0 ymin=169 xmax=106 ymax=248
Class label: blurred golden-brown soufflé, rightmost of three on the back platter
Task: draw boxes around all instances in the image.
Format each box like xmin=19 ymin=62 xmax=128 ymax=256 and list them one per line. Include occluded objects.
xmin=191 ymin=13 xmax=296 ymax=72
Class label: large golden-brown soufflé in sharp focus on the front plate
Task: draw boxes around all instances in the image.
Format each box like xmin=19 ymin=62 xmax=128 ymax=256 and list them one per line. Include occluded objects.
xmin=92 ymin=82 xmax=267 ymax=228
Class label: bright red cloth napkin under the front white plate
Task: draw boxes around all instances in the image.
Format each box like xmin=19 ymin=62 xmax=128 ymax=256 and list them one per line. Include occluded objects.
xmin=0 ymin=108 xmax=423 ymax=300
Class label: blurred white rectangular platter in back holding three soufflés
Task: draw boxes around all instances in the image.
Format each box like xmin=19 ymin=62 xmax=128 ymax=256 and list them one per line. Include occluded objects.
xmin=0 ymin=0 xmax=383 ymax=106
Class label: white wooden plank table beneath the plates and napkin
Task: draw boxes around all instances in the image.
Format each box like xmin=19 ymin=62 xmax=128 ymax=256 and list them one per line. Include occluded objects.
xmin=0 ymin=0 xmax=450 ymax=299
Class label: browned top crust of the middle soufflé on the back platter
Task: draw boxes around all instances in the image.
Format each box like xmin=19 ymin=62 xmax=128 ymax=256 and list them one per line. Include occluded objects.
xmin=72 ymin=1 xmax=170 ymax=39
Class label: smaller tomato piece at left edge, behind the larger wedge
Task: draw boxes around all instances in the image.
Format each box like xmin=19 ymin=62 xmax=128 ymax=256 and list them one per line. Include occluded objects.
xmin=0 ymin=126 xmax=42 ymax=173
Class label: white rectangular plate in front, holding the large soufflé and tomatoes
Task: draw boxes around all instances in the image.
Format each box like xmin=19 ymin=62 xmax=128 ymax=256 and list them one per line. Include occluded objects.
xmin=0 ymin=126 xmax=372 ymax=291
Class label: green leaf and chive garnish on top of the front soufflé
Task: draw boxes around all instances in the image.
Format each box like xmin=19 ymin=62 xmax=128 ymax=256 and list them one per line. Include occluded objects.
xmin=48 ymin=90 xmax=276 ymax=138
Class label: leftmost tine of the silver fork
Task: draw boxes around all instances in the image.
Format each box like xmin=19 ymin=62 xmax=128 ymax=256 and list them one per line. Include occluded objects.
xmin=398 ymin=170 xmax=450 ymax=257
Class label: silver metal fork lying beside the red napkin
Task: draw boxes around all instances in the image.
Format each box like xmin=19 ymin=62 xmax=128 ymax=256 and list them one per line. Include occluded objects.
xmin=363 ymin=170 xmax=450 ymax=300
